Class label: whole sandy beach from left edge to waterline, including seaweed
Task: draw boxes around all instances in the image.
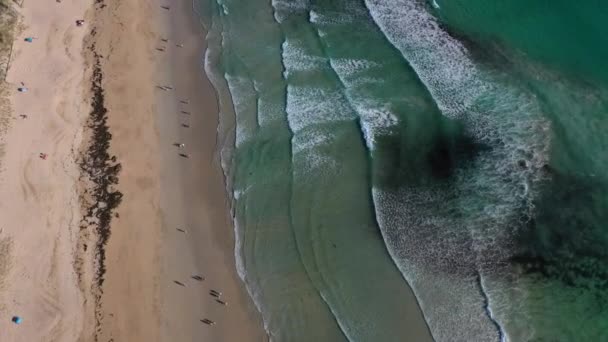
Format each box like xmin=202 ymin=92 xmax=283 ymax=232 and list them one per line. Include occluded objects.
xmin=0 ymin=0 xmax=267 ymax=341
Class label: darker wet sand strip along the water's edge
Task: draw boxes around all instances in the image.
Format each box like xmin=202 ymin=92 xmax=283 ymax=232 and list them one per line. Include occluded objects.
xmin=158 ymin=0 xmax=267 ymax=341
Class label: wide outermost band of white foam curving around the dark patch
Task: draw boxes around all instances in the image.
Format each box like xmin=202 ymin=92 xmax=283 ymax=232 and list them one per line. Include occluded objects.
xmin=365 ymin=0 xmax=549 ymax=341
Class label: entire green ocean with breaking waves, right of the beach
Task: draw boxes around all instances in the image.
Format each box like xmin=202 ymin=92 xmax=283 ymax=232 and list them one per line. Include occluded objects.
xmin=195 ymin=0 xmax=608 ymax=341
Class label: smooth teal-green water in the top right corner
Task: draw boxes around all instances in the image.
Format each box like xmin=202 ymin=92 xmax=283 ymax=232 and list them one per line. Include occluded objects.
xmin=435 ymin=0 xmax=608 ymax=81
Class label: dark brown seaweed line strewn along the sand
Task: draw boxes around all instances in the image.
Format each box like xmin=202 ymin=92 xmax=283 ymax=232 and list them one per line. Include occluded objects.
xmin=79 ymin=37 xmax=122 ymax=341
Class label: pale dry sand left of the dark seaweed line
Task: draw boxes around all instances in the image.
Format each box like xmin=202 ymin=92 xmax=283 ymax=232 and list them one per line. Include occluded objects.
xmin=0 ymin=0 xmax=92 ymax=342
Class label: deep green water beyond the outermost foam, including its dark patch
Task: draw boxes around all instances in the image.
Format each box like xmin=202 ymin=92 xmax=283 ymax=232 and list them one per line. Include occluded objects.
xmin=436 ymin=0 xmax=608 ymax=341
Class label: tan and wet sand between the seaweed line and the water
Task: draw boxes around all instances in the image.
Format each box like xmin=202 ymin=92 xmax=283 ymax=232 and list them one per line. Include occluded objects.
xmin=89 ymin=0 xmax=265 ymax=341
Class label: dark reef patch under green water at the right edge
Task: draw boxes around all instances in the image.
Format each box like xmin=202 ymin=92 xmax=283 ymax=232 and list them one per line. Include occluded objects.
xmin=510 ymin=170 xmax=608 ymax=290
